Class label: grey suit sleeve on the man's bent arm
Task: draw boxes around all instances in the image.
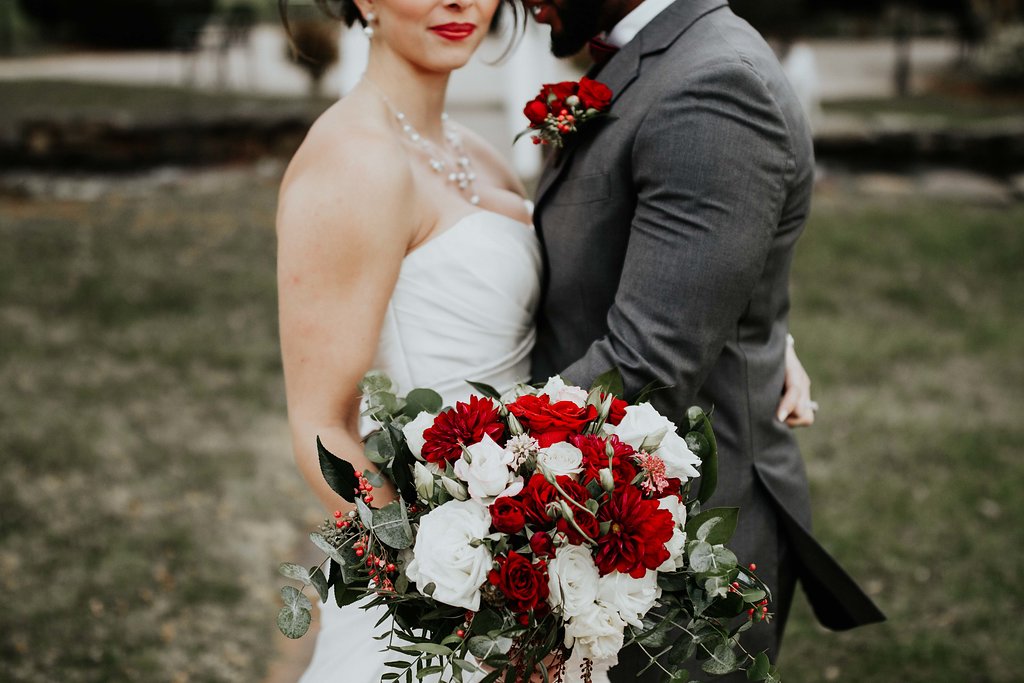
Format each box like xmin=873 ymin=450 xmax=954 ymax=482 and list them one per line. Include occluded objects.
xmin=563 ymin=61 xmax=794 ymax=413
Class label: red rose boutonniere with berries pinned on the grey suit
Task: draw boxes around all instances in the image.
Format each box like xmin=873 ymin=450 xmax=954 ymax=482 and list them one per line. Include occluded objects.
xmin=516 ymin=77 xmax=611 ymax=147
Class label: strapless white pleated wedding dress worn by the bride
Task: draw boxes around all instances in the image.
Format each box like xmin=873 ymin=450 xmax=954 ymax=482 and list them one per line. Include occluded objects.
xmin=300 ymin=211 xmax=606 ymax=683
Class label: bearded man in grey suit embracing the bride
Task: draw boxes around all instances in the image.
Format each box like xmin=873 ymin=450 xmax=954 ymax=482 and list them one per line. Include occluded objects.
xmin=523 ymin=0 xmax=884 ymax=682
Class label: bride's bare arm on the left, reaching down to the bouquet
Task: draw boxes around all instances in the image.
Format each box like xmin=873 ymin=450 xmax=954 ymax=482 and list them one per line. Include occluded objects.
xmin=276 ymin=129 xmax=416 ymax=511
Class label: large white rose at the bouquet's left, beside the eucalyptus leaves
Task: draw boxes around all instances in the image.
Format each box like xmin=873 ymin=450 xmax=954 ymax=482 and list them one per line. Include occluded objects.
xmin=406 ymin=501 xmax=493 ymax=611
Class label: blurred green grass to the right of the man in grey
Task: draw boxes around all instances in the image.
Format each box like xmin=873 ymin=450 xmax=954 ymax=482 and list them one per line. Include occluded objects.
xmin=781 ymin=191 xmax=1024 ymax=683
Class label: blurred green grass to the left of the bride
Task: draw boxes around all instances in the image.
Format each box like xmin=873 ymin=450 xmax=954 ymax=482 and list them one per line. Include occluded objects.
xmin=0 ymin=174 xmax=309 ymax=683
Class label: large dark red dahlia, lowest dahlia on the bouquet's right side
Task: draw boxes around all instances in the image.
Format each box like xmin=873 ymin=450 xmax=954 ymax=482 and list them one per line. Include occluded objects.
xmin=594 ymin=486 xmax=675 ymax=579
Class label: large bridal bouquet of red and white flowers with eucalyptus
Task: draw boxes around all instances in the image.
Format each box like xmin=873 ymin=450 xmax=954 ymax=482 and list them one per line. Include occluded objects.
xmin=278 ymin=372 xmax=778 ymax=683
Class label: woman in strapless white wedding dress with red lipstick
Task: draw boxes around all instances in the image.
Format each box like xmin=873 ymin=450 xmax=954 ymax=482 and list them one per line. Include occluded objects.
xmin=278 ymin=0 xmax=806 ymax=683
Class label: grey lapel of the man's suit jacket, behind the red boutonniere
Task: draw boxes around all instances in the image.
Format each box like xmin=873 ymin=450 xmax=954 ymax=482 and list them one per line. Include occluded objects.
xmin=535 ymin=0 xmax=728 ymax=206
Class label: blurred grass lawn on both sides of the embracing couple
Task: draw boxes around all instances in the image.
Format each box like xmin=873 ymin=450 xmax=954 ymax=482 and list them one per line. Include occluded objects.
xmin=0 ymin=169 xmax=1024 ymax=683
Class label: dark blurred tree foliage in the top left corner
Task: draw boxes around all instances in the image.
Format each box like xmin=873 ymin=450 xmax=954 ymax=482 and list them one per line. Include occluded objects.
xmin=17 ymin=0 xmax=216 ymax=48
